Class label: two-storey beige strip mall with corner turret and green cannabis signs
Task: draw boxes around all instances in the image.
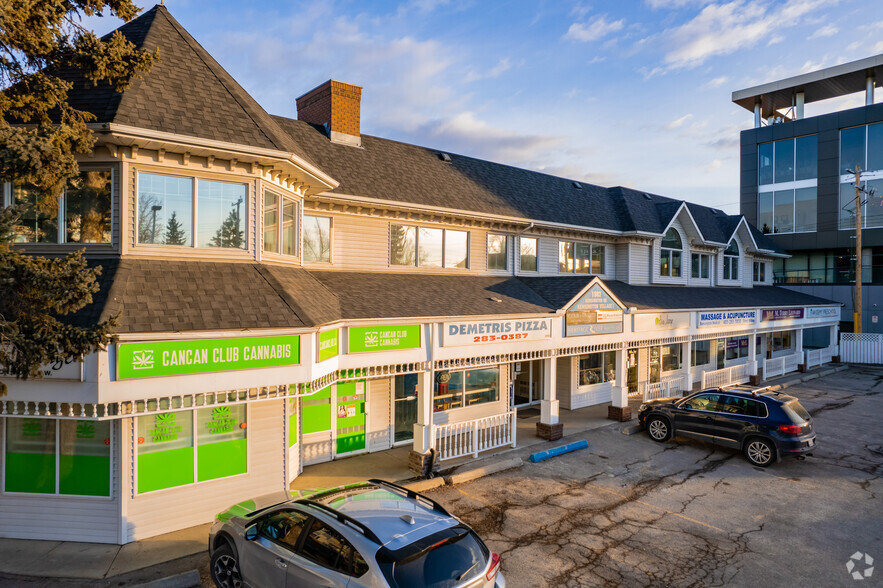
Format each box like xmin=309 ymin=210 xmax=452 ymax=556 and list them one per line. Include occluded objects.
xmin=0 ymin=6 xmax=839 ymax=543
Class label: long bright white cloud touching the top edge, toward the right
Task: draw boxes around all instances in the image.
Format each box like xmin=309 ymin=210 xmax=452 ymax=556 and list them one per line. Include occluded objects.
xmin=662 ymin=0 xmax=824 ymax=69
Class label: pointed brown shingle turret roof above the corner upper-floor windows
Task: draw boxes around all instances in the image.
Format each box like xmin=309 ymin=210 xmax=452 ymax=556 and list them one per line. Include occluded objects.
xmin=62 ymin=5 xmax=309 ymax=161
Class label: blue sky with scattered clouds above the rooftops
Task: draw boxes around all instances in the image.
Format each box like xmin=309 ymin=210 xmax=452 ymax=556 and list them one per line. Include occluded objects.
xmin=86 ymin=0 xmax=883 ymax=214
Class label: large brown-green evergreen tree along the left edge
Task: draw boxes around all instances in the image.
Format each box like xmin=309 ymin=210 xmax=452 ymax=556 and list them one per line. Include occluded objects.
xmin=0 ymin=0 xmax=158 ymax=396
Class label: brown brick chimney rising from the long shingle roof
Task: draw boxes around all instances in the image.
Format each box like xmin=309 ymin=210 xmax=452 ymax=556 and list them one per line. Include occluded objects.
xmin=297 ymin=80 xmax=362 ymax=147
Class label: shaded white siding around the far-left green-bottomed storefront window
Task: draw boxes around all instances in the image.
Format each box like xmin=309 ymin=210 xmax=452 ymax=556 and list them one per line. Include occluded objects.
xmin=0 ymin=418 xmax=121 ymax=543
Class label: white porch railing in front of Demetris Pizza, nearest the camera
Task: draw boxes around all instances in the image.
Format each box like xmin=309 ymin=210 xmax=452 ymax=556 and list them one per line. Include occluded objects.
xmin=432 ymin=410 xmax=517 ymax=460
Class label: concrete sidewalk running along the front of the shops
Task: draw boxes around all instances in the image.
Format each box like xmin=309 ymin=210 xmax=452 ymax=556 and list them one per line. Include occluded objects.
xmin=0 ymin=364 xmax=848 ymax=581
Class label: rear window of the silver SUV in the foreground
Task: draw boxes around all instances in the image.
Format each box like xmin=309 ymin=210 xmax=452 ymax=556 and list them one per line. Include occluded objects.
xmin=378 ymin=527 xmax=488 ymax=588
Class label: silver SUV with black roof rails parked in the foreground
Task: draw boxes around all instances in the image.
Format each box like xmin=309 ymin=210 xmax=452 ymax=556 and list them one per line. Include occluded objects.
xmin=209 ymin=480 xmax=506 ymax=588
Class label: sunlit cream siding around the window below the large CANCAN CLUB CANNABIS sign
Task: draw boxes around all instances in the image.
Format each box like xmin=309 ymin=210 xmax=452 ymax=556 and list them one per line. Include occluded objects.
xmin=123 ymin=400 xmax=288 ymax=541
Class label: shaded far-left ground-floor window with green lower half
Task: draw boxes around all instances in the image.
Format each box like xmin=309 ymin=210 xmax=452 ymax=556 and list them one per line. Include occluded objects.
xmin=4 ymin=418 xmax=111 ymax=496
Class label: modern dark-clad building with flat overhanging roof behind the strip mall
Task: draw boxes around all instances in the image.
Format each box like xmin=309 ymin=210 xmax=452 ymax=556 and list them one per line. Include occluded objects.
xmin=733 ymin=55 xmax=883 ymax=333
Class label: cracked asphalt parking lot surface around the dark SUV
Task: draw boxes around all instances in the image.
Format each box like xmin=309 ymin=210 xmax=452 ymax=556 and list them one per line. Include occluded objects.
xmin=428 ymin=367 xmax=883 ymax=588
